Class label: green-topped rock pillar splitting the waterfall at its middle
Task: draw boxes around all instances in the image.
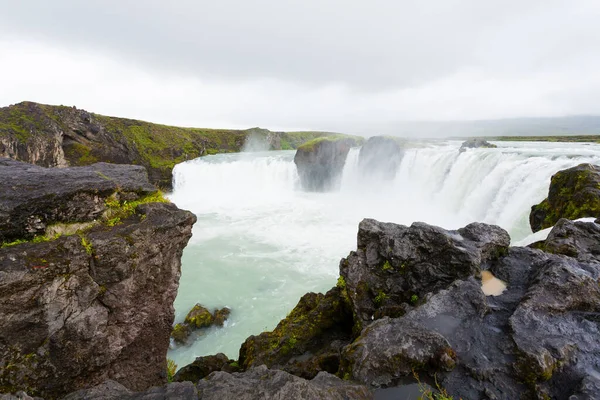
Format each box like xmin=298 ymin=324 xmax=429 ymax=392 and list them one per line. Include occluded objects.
xmin=294 ymin=135 xmax=362 ymax=192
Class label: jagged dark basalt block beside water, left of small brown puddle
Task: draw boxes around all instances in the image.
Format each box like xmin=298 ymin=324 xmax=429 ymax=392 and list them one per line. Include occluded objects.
xmin=340 ymin=219 xmax=510 ymax=333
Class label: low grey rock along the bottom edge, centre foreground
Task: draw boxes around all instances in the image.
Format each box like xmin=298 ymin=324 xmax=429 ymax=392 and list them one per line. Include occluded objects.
xmin=197 ymin=365 xmax=373 ymax=400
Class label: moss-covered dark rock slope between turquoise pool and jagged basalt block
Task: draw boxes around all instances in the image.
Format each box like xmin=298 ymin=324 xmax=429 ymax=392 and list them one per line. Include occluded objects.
xmin=239 ymin=288 xmax=352 ymax=379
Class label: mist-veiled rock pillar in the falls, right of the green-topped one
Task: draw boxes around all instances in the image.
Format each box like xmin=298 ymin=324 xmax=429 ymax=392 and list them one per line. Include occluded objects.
xmin=358 ymin=136 xmax=404 ymax=180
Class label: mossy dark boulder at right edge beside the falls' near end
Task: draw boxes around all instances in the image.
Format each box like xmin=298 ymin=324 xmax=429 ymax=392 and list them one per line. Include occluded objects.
xmin=529 ymin=164 xmax=600 ymax=232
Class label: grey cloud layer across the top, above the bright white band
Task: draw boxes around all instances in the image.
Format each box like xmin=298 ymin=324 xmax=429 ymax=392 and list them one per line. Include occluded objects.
xmin=0 ymin=0 xmax=600 ymax=90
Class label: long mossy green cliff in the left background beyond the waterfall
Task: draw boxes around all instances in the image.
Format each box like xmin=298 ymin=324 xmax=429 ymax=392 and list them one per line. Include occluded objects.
xmin=0 ymin=102 xmax=338 ymax=189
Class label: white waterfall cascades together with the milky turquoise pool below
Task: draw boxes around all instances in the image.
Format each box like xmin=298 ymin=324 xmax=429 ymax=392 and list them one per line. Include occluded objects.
xmin=169 ymin=142 xmax=600 ymax=366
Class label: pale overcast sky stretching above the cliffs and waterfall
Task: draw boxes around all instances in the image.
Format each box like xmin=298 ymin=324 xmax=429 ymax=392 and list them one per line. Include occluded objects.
xmin=0 ymin=0 xmax=600 ymax=131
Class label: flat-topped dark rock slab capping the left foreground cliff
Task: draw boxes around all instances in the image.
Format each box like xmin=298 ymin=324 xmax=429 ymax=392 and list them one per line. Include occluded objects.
xmin=0 ymin=158 xmax=156 ymax=242
